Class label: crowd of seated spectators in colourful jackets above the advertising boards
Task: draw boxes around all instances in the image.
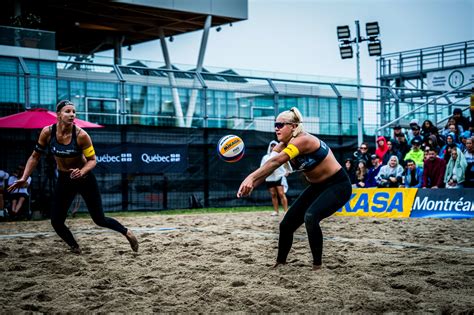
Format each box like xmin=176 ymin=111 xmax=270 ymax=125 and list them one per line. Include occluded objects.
xmin=345 ymin=107 xmax=474 ymax=188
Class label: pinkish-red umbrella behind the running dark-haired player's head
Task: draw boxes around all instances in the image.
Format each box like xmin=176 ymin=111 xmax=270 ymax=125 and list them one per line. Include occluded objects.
xmin=0 ymin=108 xmax=104 ymax=129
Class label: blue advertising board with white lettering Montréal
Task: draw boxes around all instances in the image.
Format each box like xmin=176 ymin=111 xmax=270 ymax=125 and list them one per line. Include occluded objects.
xmin=410 ymin=189 xmax=474 ymax=219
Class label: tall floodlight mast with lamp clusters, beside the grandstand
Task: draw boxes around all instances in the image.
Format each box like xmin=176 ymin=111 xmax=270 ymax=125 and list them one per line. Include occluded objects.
xmin=337 ymin=21 xmax=382 ymax=146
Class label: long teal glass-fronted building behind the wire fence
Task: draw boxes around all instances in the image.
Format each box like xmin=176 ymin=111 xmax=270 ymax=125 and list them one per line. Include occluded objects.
xmin=0 ymin=29 xmax=357 ymax=135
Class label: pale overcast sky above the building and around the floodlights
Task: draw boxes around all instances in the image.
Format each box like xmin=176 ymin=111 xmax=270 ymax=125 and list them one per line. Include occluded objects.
xmin=103 ymin=0 xmax=474 ymax=85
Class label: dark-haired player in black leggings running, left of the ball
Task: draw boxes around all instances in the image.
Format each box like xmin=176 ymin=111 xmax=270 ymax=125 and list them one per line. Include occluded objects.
xmin=8 ymin=101 xmax=138 ymax=254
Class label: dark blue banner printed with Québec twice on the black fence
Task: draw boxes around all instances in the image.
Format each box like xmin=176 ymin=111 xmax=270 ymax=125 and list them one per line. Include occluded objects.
xmin=94 ymin=143 xmax=188 ymax=174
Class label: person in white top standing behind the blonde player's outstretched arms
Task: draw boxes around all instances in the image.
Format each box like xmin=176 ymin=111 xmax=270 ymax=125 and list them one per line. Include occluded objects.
xmin=260 ymin=140 xmax=291 ymax=216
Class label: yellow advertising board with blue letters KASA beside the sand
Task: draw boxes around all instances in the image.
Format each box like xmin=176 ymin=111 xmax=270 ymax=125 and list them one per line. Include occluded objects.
xmin=336 ymin=188 xmax=417 ymax=218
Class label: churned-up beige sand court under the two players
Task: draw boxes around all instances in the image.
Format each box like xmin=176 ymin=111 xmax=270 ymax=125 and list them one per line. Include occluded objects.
xmin=0 ymin=212 xmax=474 ymax=314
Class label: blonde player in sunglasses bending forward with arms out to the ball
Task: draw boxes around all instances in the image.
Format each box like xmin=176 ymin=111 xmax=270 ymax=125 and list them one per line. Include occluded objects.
xmin=237 ymin=107 xmax=352 ymax=270
